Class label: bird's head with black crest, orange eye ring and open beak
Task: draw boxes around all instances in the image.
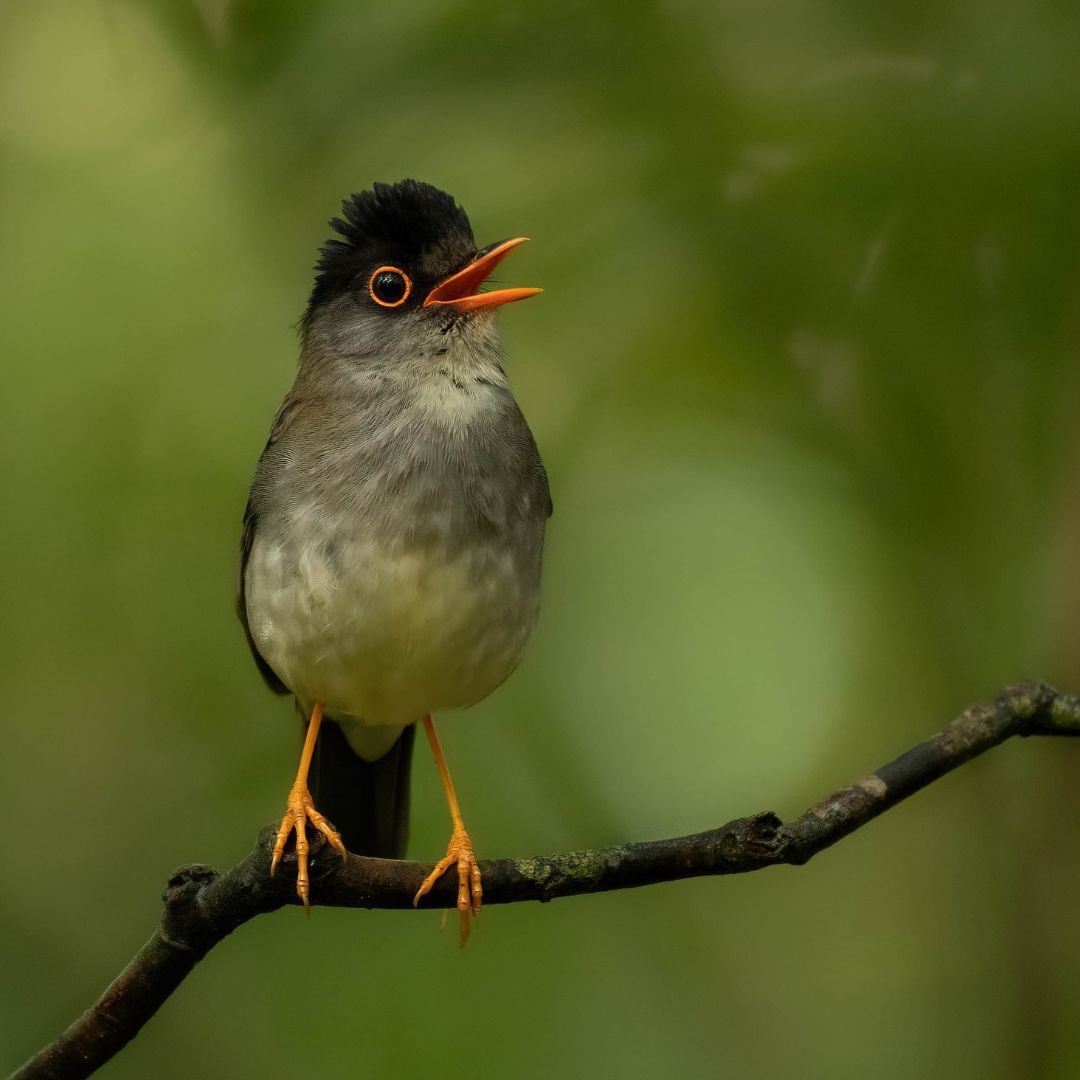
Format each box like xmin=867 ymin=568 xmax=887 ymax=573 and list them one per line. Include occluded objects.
xmin=303 ymin=180 xmax=541 ymax=356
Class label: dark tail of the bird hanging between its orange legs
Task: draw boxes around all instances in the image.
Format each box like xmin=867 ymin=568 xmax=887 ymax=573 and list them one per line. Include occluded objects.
xmin=309 ymin=719 xmax=416 ymax=859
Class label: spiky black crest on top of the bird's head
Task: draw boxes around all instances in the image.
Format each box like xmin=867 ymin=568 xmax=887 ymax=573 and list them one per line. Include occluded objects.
xmin=307 ymin=180 xmax=476 ymax=318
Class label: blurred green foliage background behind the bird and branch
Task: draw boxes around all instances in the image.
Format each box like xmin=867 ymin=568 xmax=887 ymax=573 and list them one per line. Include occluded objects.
xmin=0 ymin=0 xmax=1080 ymax=1080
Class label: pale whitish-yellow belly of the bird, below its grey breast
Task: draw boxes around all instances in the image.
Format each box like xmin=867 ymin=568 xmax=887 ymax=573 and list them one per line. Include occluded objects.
xmin=246 ymin=529 xmax=539 ymax=743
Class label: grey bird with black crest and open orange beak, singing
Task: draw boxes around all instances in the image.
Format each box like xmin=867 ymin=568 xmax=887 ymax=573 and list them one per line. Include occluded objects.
xmin=237 ymin=179 xmax=552 ymax=945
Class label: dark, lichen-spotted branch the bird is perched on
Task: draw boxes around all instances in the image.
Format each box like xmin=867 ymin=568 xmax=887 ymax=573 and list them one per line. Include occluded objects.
xmin=12 ymin=683 xmax=1080 ymax=1080
